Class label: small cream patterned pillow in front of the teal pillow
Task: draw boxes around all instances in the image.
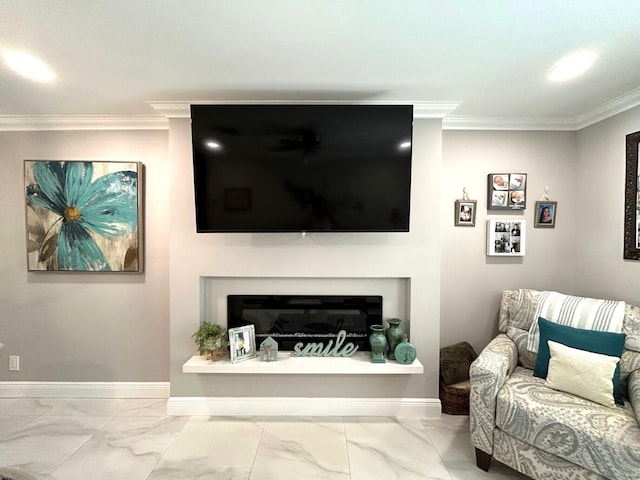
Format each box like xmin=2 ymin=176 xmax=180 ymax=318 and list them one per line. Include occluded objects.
xmin=545 ymin=340 xmax=620 ymax=407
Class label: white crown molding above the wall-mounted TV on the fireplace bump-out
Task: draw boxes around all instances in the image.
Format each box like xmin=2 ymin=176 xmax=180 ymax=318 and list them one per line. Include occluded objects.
xmin=147 ymin=100 xmax=460 ymax=118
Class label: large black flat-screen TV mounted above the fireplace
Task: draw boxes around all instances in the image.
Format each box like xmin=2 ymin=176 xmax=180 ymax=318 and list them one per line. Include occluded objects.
xmin=191 ymin=104 xmax=413 ymax=233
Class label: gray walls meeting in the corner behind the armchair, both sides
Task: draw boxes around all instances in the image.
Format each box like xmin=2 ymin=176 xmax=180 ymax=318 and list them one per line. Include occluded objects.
xmin=440 ymin=107 xmax=640 ymax=349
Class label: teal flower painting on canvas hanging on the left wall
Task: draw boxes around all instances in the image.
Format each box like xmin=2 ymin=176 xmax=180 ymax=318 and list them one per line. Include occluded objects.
xmin=25 ymin=160 xmax=142 ymax=272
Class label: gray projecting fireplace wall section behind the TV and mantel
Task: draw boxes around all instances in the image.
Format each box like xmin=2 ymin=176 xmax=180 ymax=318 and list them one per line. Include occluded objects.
xmin=169 ymin=119 xmax=442 ymax=398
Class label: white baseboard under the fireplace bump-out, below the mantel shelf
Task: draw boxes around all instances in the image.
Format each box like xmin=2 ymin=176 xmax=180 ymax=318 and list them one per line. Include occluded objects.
xmin=167 ymin=397 xmax=442 ymax=417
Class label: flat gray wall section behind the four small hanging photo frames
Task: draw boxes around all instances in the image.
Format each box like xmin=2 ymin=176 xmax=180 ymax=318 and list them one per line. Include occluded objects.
xmin=440 ymin=131 xmax=577 ymax=351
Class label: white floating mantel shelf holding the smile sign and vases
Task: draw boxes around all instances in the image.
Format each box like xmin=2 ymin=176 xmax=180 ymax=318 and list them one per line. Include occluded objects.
xmin=182 ymin=352 xmax=424 ymax=375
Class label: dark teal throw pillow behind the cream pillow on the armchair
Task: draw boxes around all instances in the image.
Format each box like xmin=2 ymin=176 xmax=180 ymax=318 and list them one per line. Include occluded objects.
xmin=533 ymin=317 xmax=626 ymax=405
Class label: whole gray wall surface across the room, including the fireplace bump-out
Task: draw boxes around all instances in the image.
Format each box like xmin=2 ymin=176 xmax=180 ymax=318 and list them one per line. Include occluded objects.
xmin=0 ymin=104 xmax=640 ymax=386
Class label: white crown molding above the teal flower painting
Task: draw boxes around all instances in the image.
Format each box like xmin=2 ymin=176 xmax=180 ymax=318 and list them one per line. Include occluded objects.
xmin=0 ymin=115 xmax=169 ymax=132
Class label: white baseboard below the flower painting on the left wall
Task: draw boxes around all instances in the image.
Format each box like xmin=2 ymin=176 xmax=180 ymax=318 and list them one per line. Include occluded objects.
xmin=0 ymin=382 xmax=169 ymax=398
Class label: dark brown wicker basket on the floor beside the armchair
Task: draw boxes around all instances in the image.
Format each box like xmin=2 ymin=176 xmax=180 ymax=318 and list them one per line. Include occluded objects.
xmin=440 ymin=342 xmax=478 ymax=415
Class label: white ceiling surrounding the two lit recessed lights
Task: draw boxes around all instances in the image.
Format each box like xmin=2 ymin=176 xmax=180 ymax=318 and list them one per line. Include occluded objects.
xmin=0 ymin=0 xmax=640 ymax=128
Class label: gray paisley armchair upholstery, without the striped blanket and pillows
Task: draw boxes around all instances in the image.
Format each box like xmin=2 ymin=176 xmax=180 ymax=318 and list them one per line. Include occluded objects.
xmin=470 ymin=289 xmax=640 ymax=480
